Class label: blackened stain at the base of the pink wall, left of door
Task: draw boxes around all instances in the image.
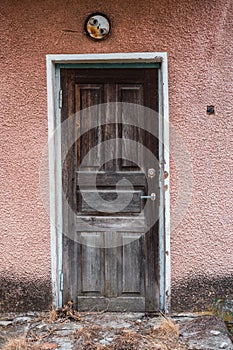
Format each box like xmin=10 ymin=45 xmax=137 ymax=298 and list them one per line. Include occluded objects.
xmin=0 ymin=276 xmax=52 ymax=313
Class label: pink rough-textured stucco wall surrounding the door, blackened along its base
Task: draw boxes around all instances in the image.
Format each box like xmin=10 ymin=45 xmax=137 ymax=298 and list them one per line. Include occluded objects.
xmin=0 ymin=0 xmax=233 ymax=309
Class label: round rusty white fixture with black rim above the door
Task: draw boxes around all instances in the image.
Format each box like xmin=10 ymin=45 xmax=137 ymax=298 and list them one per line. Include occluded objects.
xmin=84 ymin=12 xmax=111 ymax=40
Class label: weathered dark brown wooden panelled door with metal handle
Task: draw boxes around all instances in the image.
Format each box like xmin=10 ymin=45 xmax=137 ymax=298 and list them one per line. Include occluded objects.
xmin=61 ymin=68 xmax=159 ymax=312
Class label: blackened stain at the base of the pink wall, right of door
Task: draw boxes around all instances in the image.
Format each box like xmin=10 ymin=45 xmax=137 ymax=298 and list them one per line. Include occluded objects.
xmin=171 ymin=275 xmax=233 ymax=312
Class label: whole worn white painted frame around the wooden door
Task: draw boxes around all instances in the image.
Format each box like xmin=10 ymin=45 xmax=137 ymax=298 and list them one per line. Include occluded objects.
xmin=46 ymin=52 xmax=171 ymax=313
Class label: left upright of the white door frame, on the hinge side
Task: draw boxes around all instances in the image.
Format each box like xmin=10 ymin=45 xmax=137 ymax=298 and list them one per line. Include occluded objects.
xmin=47 ymin=58 xmax=62 ymax=307
